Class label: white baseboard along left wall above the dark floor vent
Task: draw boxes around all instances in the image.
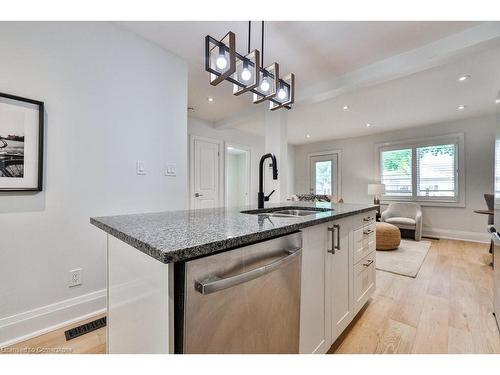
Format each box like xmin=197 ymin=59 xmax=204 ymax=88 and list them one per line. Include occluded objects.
xmin=0 ymin=289 xmax=106 ymax=348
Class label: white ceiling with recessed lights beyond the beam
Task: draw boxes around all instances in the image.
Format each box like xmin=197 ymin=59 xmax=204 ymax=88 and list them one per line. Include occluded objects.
xmin=236 ymin=43 xmax=500 ymax=144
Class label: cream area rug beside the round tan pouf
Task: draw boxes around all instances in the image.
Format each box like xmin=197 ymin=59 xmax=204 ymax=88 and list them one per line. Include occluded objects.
xmin=377 ymin=240 xmax=431 ymax=277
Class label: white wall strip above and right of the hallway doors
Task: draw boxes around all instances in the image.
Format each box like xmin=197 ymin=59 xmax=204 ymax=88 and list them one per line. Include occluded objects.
xmin=188 ymin=117 xmax=265 ymax=205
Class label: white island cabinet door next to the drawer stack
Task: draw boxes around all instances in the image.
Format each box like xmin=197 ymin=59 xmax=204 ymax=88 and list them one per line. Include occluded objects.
xmin=326 ymin=217 xmax=354 ymax=342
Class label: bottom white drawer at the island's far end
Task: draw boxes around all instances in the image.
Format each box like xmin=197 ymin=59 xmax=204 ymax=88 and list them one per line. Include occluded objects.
xmin=353 ymin=251 xmax=377 ymax=314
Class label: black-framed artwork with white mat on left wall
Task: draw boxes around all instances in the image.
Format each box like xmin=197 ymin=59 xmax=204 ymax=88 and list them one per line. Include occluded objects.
xmin=0 ymin=93 xmax=44 ymax=192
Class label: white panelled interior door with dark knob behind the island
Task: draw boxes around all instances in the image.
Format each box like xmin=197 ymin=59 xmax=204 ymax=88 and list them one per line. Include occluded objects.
xmin=191 ymin=138 xmax=221 ymax=209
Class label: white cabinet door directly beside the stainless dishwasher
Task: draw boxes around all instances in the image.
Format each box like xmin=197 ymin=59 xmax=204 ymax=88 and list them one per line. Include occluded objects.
xmin=299 ymin=224 xmax=331 ymax=354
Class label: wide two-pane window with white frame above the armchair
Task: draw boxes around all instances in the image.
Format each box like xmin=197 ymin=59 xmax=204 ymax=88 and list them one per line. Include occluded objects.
xmin=379 ymin=134 xmax=463 ymax=203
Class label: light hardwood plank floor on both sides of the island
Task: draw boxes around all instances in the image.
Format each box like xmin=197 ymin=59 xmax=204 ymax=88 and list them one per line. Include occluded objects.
xmin=3 ymin=240 xmax=500 ymax=354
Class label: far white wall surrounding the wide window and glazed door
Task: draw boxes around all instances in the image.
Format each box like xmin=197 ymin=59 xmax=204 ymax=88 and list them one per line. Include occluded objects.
xmin=295 ymin=116 xmax=495 ymax=240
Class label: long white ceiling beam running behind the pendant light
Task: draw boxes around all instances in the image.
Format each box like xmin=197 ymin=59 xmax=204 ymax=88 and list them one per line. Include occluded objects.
xmin=214 ymin=22 xmax=500 ymax=128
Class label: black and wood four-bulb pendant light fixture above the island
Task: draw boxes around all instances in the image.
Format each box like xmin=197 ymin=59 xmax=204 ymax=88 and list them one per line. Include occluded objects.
xmin=205 ymin=21 xmax=295 ymax=110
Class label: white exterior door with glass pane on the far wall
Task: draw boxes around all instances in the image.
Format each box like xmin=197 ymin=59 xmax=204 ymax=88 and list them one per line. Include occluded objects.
xmin=309 ymin=154 xmax=340 ymax=197
